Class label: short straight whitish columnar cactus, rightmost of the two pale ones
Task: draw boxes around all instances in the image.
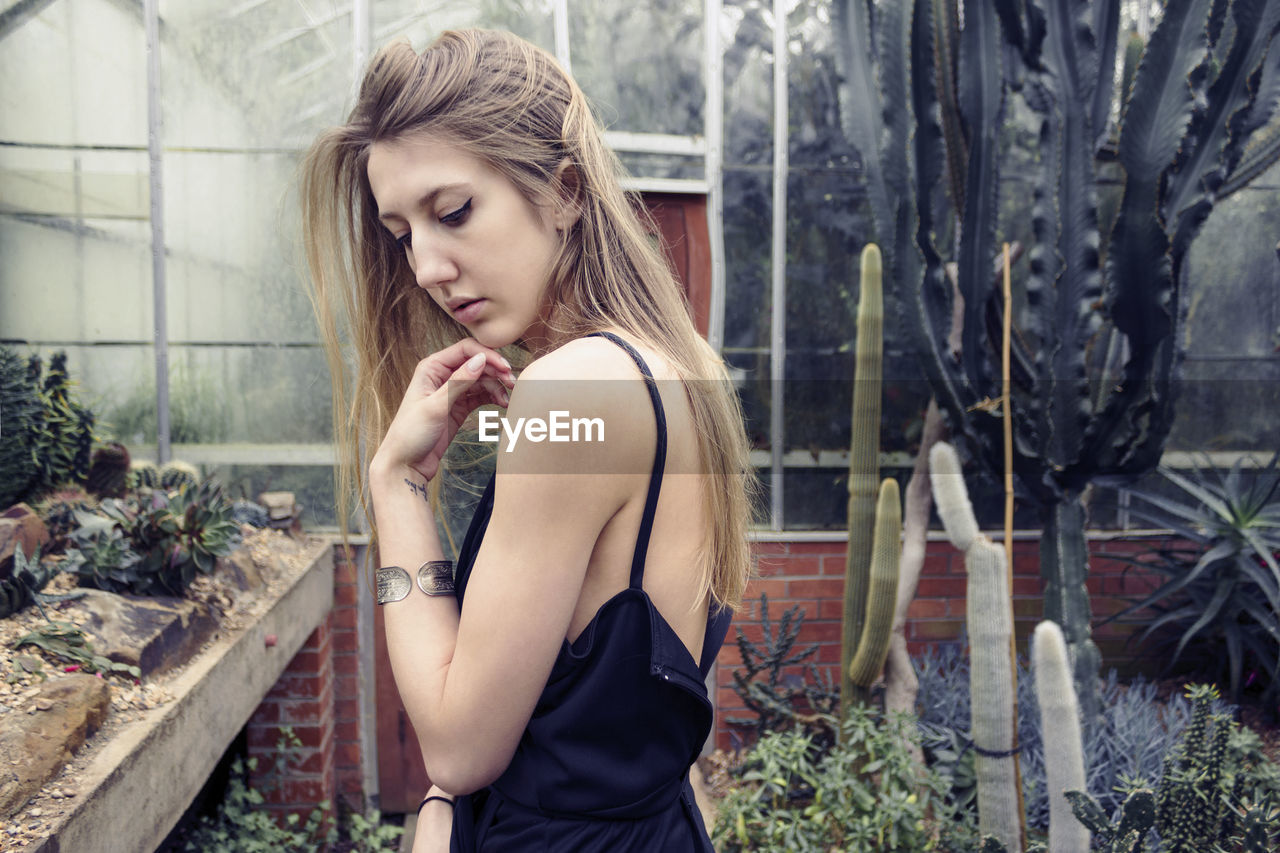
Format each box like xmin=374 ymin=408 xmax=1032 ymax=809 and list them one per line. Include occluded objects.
xmin=1032 ymin=621 xmax=1089 ymax=853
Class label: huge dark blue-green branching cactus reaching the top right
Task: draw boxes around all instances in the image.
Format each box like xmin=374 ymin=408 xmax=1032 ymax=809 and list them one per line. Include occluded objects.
xmin=833 ymin=0 xmax=1280 ymax=719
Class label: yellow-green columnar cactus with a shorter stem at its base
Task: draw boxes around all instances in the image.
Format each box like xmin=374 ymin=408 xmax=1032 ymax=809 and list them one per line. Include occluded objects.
xmin=840 ymin=243 xmax=902 ymax=707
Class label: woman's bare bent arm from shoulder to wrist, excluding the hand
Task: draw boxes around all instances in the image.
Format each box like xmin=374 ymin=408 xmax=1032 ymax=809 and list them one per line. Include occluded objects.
xmin=370 ymin=341 xmax=654 ymax=793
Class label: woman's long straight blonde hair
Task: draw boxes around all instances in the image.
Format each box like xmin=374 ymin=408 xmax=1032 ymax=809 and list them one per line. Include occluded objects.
xmin=301 ymin=29 xmax=753 ymax=607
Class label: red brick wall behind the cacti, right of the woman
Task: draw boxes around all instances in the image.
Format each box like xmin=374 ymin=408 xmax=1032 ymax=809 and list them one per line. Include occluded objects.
xmin=714 ymin=538 xmax=1172 ymax=749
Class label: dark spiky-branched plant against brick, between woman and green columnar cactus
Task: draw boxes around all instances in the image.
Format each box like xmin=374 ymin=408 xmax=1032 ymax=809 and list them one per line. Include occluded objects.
xmin=728 ymin=594 xmax=840 ymax=739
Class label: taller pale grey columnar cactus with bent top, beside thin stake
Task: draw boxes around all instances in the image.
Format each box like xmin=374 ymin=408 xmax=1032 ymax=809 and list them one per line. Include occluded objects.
xmin=929 ymin=442 xmax=1023 ymax=853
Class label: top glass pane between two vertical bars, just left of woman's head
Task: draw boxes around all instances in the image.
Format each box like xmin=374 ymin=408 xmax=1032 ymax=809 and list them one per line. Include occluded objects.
xmin=160 ymin=0 xmax=355 ymax=149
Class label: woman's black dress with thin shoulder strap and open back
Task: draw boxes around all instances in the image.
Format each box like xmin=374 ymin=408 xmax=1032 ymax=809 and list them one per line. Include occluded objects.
xmin=451 ymin=332 xmax=731 ymax=853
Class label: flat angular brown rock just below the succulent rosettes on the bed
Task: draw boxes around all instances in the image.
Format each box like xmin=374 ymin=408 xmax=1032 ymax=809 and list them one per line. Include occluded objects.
xmin=72 ymin=589 xmax=218 ymax=675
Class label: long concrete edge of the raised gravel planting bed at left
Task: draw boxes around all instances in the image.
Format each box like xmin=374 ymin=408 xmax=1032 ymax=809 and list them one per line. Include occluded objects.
xmin=24 ymin=539 xmax=333 ymax=853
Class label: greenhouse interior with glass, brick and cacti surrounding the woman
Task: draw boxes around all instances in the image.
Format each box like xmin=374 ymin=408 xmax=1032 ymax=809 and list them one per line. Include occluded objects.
xmin=0 ymin=0 xmax=1280 ymax=853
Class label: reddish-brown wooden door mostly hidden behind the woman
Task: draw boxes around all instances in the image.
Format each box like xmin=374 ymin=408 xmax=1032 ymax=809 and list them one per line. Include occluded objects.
xmin=374 ymin=192 xmax=712 ymax=812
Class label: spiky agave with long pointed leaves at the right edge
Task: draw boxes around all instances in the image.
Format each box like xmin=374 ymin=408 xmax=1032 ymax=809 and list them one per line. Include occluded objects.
xmin=1114 ymin=453 xmax=1280 ymax=703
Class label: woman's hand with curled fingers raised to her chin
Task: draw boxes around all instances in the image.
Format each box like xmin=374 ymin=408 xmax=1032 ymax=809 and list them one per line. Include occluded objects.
xmin=370 ymin=338 xmax=516 ymax=480
